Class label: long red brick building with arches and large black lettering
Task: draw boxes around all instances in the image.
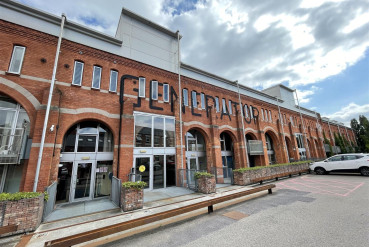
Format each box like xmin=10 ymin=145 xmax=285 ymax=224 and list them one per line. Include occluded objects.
xmin=0 ymin=1 xmax=356 ymax=202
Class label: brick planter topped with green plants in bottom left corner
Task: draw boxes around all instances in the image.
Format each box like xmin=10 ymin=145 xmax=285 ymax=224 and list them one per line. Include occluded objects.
xmin=0 ymin=192 xmax=48 ymax=237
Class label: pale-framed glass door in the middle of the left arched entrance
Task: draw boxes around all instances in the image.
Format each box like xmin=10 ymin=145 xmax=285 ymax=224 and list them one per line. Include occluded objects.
xmin=71 ymin=161 xmax=95 ymax=201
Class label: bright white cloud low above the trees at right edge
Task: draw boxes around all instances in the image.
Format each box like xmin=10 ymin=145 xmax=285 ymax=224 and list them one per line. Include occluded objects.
xmin=322 ymin=103 xmax=369 ymax=126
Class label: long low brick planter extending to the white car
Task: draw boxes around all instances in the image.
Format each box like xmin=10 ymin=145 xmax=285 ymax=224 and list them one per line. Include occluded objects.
xmin=233 ymin=163 xmax=309 ymax=186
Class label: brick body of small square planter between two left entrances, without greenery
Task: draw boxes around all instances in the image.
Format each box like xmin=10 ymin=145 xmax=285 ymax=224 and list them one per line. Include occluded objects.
xmin=120 ymin=187 xmax=143 ymax=212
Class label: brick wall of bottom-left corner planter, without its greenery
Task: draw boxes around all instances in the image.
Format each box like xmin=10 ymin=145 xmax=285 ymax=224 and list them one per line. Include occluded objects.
xmin=0 ymin=194 xmax=44 ymax=237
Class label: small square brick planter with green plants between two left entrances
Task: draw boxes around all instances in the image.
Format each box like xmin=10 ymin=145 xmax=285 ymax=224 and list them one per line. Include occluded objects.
xmin=120 ymin=181 xmax=146 ymax=212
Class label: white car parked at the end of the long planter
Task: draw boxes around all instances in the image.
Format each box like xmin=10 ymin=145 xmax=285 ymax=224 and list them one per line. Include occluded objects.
xmin=310 ymin=153 xmax=369 ymax=176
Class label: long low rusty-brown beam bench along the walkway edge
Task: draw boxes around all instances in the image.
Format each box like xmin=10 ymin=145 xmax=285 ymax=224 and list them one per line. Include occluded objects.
xmin=45 ymin=184 xmax=275 ymax=246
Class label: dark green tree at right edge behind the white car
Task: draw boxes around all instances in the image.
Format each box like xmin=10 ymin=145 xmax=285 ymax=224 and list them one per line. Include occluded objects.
xmin=351 ymin=115 xmax=369 ymax=153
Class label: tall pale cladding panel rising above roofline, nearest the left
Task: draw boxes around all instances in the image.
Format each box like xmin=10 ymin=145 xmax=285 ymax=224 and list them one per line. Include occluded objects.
xmin=116 ymin=14 xmax=178 ymax=73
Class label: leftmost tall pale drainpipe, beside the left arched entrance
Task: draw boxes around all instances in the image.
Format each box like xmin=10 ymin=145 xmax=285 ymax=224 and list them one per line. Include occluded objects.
xmin=33 ymin=14 xmax=67 ymax=192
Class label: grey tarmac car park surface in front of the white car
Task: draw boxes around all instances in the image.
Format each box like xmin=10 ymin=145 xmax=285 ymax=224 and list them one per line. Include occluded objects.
xmin=104 ymin=175 xmax=369 ymax=247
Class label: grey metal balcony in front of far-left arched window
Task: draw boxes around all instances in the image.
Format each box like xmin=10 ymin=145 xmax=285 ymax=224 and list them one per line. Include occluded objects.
xmin=0 ymin=127 xmax=24 ymax=164
